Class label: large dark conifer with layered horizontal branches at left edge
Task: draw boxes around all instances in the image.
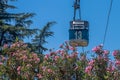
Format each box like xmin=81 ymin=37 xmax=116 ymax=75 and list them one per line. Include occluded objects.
xmin=0 ymin=0 xmax=37 ymax=46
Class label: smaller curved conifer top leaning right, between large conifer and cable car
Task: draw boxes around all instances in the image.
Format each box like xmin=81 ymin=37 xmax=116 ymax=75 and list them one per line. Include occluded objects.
xmin=32 ymin=22 xmax=56 ymax=54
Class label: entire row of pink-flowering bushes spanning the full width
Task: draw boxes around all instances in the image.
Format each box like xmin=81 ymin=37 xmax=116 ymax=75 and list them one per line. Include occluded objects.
xmin=0 ymin=42 xmax=120 ymax=80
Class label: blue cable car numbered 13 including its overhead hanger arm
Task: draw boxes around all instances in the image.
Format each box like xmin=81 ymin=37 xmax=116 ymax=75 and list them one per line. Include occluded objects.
xmin=69 ymin=0 xmax=89 ymax=47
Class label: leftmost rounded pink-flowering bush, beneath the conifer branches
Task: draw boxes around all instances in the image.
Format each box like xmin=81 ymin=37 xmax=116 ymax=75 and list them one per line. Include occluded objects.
xmin=0 ymin=42 xmax=40 ymax=80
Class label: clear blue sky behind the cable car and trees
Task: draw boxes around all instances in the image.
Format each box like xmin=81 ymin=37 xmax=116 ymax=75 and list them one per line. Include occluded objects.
xmin=9 ymin=0 xmax=120 ymax=51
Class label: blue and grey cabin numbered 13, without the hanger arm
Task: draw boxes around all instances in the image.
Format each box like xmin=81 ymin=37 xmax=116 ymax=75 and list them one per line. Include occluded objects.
xmin=69 ymin=20 xmax=89 ymax=47
